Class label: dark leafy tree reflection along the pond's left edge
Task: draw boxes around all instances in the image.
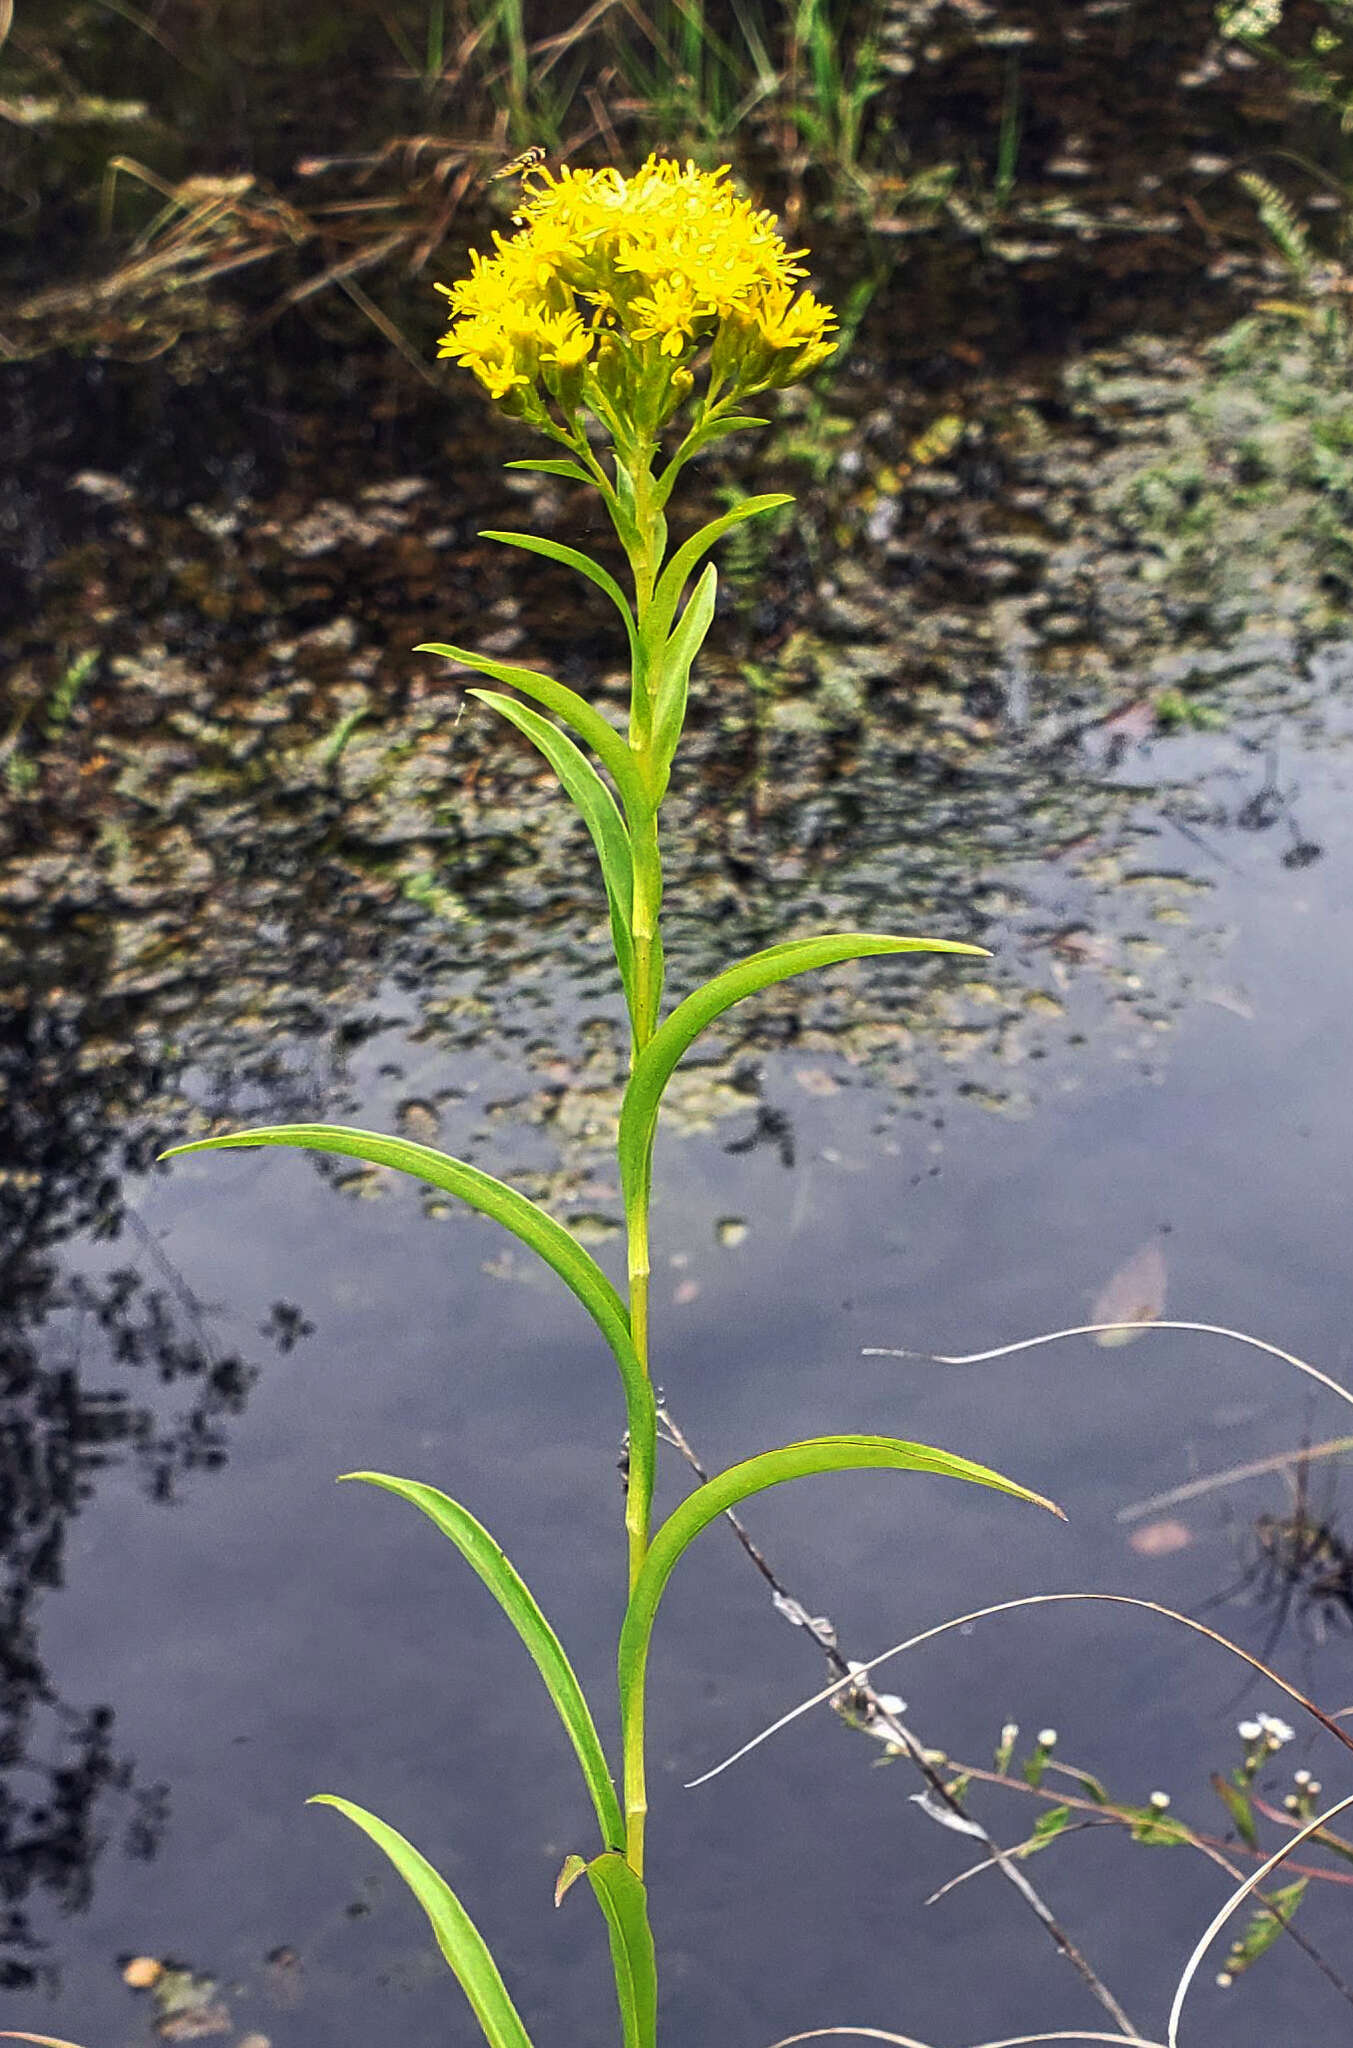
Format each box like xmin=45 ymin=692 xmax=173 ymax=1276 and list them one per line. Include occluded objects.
xmin=0 ymin=1001 xmax=305 ymax=1989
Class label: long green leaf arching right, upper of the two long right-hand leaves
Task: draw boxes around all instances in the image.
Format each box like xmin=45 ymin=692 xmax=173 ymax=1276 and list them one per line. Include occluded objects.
xmin=620 ymin=932 xmax=987 ymax=1202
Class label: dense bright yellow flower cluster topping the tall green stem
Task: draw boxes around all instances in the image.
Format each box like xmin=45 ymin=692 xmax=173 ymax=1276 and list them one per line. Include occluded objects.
xmin=438 ymin=156 xmax=835 ymax=432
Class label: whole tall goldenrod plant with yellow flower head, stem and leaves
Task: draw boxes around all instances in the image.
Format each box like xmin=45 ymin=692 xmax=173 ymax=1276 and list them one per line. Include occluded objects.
xmin=155 ymin=158 xmax=1056 ymax=2048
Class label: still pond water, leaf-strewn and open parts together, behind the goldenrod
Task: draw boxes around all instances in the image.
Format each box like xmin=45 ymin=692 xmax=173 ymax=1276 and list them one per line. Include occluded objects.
xmin=0 ymin=32 xmax=1353 ymax=2048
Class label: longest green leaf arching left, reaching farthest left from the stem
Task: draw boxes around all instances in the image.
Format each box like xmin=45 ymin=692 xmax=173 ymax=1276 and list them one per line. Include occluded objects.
xmin=162 ymin=1124 xmax=641 ymax=1372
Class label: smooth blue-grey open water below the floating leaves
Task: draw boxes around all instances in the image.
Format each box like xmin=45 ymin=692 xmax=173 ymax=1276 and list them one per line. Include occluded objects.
xmin=4 ymin=618 xmax=1353 ymax=2048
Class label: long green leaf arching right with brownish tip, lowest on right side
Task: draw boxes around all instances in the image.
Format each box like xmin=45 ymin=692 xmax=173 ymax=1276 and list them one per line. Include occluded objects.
xmin=618 ymin=1436 xmax=1064 ymax=1729
